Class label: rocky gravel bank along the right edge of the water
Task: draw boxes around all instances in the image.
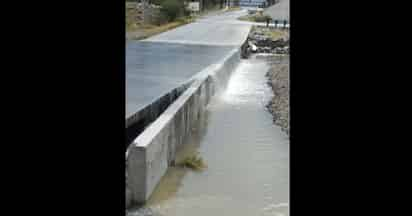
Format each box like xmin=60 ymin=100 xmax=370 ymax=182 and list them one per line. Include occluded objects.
xmin=242 ymin=26 xmax=289 ymax=135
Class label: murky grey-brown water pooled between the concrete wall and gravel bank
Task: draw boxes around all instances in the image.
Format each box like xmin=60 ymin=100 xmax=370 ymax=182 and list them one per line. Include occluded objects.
xmin=128 ymin=55 xmax=289 ymax=216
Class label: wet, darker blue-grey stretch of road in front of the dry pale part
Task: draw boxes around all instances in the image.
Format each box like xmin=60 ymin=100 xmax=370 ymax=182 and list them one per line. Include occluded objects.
xmin=126 ymin=41 xmax=234 ymax=117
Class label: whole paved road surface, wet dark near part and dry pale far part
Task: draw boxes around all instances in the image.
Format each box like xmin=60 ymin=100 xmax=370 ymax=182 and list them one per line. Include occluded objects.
xmin=126 ymin=11 xmax=251 ymax=118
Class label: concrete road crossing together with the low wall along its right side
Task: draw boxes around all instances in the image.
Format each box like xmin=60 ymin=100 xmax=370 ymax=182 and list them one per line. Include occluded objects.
xmin=126 ymin=10 xmax=251 ymax=209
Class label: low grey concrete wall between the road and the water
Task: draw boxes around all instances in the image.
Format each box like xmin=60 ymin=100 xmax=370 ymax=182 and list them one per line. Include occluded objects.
xmin=126 ymin=49 xmax=240 ymax=205
